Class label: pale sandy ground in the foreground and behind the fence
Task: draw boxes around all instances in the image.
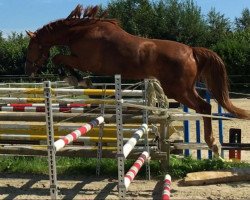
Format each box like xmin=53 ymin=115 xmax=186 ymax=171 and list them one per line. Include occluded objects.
xmin=0 ymin=99 xmax=250 ymax=200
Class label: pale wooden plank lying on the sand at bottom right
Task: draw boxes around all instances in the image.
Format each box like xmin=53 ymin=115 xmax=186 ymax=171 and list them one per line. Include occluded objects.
xmin=183 ymin=168 xmax=250 ymax=186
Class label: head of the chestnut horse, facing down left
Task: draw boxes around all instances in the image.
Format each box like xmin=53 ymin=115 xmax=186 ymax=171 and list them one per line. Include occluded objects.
xmin=25 ymin=31 xmax=49 ymax=76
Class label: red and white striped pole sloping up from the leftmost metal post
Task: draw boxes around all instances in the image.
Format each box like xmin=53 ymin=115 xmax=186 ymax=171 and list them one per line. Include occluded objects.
xmin=54 ymin=116 xmax=104 ymax=151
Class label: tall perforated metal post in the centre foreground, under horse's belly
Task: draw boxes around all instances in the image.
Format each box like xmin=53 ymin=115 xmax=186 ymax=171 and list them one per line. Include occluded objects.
xmin=115 ymin=75 xmax=126 ymax=199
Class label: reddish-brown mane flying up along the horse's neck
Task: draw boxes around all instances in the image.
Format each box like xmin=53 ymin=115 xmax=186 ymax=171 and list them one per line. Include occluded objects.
xmin=36 ymin=4 xmax=119 ymax=33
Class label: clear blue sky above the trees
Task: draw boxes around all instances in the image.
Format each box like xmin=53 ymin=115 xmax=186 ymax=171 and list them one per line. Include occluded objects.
xmin=0 ymin=0 xmax=250 ymax=37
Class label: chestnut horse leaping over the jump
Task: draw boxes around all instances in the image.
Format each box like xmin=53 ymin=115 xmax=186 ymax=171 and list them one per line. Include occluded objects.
xmin=26 ymin=7 xmax=250 ymax=158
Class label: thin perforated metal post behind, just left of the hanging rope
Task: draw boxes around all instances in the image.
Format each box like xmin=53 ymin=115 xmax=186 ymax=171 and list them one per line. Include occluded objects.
xmin=143 ymin=80 xmax=151 ymax=180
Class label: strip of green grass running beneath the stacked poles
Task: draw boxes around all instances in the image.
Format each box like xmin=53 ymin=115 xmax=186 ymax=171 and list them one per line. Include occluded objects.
xmin=0 ymin=156 xmax=250 ymax=179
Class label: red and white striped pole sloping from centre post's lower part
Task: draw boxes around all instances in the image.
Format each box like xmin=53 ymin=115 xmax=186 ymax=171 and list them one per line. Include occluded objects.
xmin=124 ymin=151 xmax=149 ymax=190
